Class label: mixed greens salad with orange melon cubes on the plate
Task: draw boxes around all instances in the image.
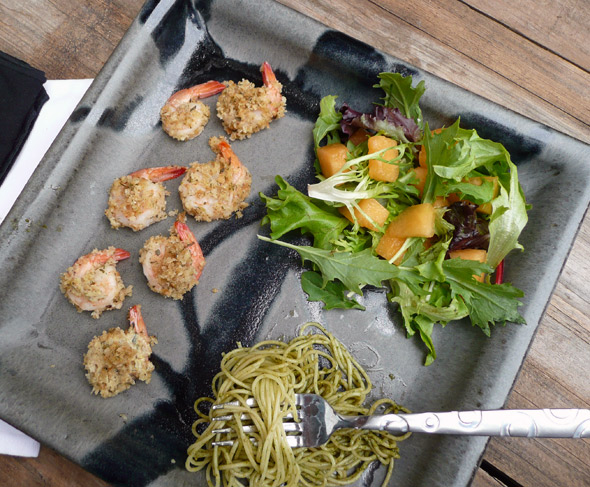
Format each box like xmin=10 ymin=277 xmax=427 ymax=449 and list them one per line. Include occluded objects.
xmin=259 ymin=73 xmax=528 ymax=365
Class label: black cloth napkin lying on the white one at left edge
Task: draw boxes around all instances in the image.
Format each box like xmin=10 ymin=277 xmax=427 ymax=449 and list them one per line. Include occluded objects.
xmin=0 ymin=51 xmax=49 ymax=184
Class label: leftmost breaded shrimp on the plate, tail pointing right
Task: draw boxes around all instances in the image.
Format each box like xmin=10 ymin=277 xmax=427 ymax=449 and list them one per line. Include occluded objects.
xmin=60 ymin=247 xmax=132 ymax=318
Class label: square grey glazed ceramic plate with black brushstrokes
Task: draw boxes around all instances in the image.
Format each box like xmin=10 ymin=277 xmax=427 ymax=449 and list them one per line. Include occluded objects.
xmin=0 ymin=0 xmax=590 ymax=487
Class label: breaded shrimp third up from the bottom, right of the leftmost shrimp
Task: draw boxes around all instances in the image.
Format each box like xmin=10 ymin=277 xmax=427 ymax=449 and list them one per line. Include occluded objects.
xmin=139 ymin=213 xmax=205 ymax=299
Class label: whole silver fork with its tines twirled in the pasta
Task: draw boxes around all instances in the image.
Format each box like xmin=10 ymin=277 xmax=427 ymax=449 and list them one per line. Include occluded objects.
xmin=213 ymin=394 xmax=590 ymax=448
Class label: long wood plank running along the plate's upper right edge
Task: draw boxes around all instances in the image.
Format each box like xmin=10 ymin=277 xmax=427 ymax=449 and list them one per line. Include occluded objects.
xmin=280 ymin=0 xmax=590 ymax=142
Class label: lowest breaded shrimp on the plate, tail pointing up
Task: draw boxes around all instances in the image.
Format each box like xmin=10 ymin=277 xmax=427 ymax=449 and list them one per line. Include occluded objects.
xmin=84 ymin=304 xmax=158 ymax=398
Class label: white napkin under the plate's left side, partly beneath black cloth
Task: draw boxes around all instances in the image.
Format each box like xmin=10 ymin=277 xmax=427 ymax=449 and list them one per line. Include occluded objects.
xmin=0 ymin=79 xmax=92 ymax=457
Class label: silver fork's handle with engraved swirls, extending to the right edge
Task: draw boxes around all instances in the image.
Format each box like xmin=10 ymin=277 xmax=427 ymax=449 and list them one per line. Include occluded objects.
xmin=356 ymin=409 xmax=590 ymax=438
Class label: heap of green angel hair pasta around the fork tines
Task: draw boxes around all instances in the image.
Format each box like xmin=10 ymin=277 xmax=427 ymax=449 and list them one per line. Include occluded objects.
xmin=186 ymin=323 xmax=408 ymax=487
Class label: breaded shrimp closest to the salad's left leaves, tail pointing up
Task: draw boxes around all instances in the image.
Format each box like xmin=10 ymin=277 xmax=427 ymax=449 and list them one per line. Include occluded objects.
xmin=178 ymin=137 xmax=252 ymax=222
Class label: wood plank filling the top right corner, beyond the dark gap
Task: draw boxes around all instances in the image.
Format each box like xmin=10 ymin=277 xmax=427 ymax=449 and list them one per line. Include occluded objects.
xmin=464 ymin=0 xmax=590 ymax=71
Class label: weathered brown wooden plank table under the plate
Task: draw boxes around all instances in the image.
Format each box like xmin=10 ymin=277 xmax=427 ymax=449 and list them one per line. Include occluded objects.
xmin=0 ymin=0 xmax=590 ymax=487
